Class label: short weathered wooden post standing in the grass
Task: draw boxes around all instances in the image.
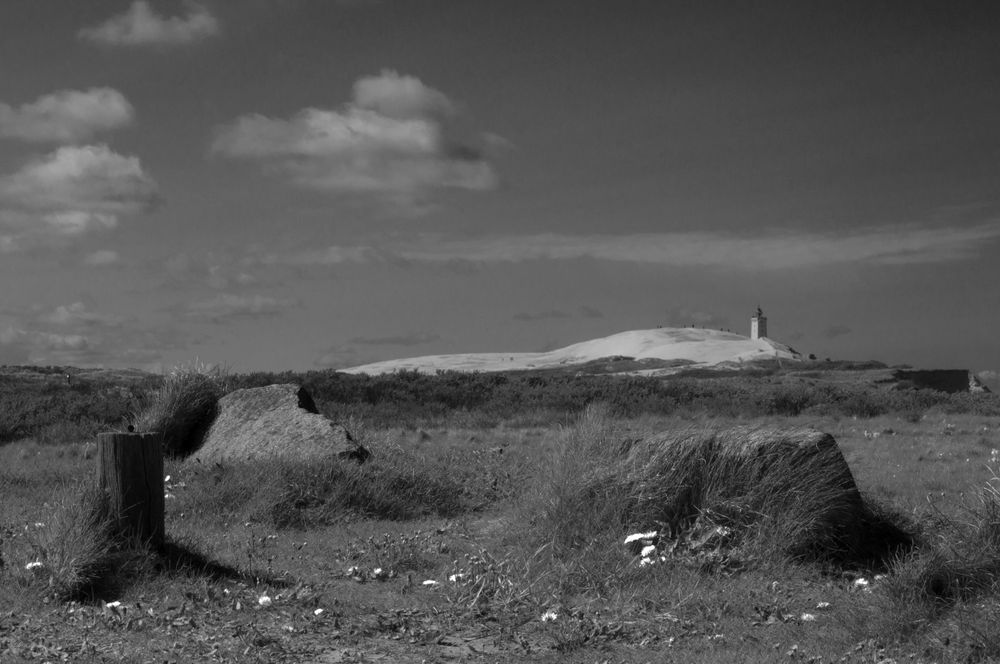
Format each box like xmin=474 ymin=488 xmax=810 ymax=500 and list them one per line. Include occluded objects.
xmin=97 ymin=433 xmax=164 ymax=549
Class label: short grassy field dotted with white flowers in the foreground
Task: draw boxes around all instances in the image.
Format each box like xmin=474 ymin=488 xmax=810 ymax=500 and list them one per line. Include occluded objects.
xmin=0 ymin=370 xmax=1000 ymax=663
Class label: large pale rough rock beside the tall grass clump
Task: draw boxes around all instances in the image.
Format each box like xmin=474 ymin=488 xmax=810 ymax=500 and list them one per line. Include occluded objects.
xmin=190 ymin=384 xmax=369 ymax=463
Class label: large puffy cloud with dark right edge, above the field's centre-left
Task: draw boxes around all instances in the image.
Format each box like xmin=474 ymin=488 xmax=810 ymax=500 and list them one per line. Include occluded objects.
xmin=212 ymin=71 xmax=497 ymax=209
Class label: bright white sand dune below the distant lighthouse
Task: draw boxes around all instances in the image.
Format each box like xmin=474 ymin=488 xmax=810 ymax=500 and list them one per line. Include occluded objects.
xmin=341 ymin=327 xmax=799 ymax=375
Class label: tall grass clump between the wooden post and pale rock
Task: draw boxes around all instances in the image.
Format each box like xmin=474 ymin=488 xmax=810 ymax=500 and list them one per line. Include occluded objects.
xmin=133 ymin=361 xmax=228 ymax=457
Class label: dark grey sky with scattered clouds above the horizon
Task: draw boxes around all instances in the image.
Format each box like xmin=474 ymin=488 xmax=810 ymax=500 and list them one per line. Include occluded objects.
xmin=0 ymin=0 xmax=1000 ymax=372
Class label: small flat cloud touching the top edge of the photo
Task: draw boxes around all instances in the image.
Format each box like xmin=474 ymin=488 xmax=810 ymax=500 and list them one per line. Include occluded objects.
xmin=77 ymin=0 xmax=219 ymax=46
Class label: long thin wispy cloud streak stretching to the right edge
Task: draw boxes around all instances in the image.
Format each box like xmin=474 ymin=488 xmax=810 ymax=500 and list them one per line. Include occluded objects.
xmin=267 ymin=221 xmax=1000 ymax=271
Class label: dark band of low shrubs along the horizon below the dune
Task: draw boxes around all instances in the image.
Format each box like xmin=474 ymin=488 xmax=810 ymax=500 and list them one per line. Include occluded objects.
xmin=0 ymin=358 xmax=1000 ymax=442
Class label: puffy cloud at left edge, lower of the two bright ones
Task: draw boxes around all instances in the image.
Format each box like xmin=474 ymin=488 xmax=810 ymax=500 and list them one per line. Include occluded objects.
xmin=0 ymin=145 xmax=159 ymax=241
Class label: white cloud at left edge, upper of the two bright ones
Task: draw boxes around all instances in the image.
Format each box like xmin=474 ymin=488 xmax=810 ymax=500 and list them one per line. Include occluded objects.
xmin=0 ymin=88 xmax=135 ymax=143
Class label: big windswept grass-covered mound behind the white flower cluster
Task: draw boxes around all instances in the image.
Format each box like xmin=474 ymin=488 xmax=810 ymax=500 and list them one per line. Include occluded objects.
xmin=531 ymin=408 xmax=909 ymax=562
